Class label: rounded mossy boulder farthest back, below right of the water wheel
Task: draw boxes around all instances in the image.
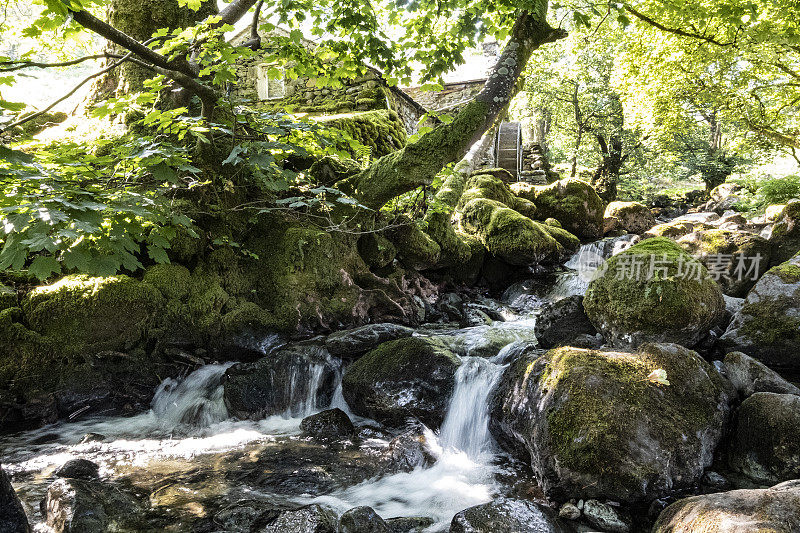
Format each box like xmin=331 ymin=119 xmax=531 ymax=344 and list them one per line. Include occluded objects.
xmin=511 ymin=178 xmax=605 ymax=239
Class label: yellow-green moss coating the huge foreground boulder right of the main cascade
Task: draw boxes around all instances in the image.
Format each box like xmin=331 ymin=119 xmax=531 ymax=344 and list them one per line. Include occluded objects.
xmin=537 ymin=345 xmax=724 ymax=497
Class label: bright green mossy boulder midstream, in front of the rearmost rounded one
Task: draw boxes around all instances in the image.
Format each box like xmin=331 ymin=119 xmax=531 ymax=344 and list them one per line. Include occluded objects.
xmin=460 ymin=198 xmax=580 ymax=266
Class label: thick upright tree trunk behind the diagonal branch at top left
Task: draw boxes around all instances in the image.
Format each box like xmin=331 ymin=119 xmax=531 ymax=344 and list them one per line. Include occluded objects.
xmin=90 ymin=0 xmax=217 ymax=103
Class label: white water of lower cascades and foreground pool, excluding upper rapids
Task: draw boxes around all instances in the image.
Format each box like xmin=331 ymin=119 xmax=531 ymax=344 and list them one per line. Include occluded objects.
xmin=0 ymin=298 xmax=535 ymax=531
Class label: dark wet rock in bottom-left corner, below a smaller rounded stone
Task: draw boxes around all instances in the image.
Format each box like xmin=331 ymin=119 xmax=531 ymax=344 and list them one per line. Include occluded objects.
xmin=42 ymin=478 xmax=144 ymax=533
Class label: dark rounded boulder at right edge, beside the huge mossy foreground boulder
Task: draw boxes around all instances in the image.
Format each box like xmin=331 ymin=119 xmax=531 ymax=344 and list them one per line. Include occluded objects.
xmin=728 ymin=392 xmax=800 ymax=483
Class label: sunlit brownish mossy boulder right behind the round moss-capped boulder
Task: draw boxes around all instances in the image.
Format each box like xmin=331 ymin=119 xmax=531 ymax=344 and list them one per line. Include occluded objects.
xmin=678 ymin=229 xmax=770 ymax=298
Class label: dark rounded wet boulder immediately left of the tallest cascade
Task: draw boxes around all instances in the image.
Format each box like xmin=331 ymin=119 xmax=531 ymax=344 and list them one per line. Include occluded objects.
xmin=342 ymin=337 xmax=461 ymax=427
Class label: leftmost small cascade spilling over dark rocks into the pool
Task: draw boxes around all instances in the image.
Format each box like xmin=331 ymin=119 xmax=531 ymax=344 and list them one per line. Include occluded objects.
xmin=150 ymin=363 xmax=232 ymax=428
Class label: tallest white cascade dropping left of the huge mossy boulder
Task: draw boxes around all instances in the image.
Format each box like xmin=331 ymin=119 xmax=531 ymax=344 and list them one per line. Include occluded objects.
xmin=439 ymin=357 xmax=504 ymax=459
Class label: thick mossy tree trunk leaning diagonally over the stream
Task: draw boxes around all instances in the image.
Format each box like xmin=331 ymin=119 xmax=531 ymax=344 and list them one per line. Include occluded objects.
xmin=337 ymin=8 xmax=567 ymax=209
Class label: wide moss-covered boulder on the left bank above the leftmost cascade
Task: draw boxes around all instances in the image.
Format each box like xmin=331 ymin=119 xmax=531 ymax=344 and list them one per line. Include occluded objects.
xmin=22 ymin=275 xmax=164 ymax=352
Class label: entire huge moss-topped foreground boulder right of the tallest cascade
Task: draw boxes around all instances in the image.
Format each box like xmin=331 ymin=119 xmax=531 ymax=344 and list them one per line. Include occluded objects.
xmin=490 ymin=344 xmax=730 ymax=502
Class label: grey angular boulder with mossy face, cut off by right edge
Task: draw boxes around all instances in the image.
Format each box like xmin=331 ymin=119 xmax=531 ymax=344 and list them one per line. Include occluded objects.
xmin=719 ymin=255 xmax=800 ymax=369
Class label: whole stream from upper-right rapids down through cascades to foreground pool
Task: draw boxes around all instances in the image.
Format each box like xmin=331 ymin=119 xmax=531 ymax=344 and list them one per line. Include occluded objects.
xmin=0 ymin=238 xmax=630 ymax=532
